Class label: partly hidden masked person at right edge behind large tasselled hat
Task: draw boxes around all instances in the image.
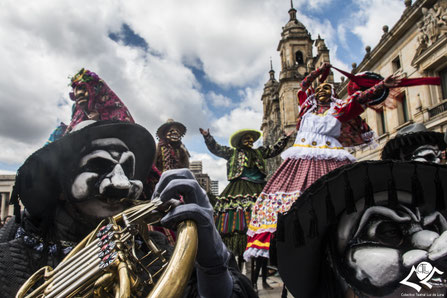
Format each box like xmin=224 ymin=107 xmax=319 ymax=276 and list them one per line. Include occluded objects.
xmin=382 ymin=123 xmax=446 ymax=163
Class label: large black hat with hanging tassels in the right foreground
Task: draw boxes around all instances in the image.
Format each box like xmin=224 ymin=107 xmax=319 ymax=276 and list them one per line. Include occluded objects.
xmin=277 ymin=161 xmax=447 ymax=298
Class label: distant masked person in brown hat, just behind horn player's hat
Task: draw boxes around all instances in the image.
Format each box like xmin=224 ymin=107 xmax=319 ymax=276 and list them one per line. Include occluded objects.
xmin=155 ymin=119 xmax=190 ymax=172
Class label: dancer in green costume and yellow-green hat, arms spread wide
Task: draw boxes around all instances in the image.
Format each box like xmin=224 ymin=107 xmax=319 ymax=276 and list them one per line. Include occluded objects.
xmin=200 ymin=128 xmax=293 ymax=287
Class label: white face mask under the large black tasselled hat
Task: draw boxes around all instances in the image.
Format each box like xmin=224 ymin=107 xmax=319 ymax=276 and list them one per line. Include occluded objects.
xmin=335 ymin=192 xmax=447 ymax=297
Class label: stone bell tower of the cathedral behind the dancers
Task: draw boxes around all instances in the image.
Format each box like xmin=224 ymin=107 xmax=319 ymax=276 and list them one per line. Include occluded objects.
xmin=261 ymin=2 xmax=333 ymax=176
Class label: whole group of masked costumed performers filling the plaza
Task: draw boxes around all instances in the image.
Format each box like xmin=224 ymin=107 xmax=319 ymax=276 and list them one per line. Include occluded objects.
xmin=0 ymin=63 xmax=447 ymax=297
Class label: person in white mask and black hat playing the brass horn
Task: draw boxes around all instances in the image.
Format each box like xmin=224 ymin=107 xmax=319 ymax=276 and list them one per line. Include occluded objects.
xmin=0 ymin=121 xmax=254 ymax=297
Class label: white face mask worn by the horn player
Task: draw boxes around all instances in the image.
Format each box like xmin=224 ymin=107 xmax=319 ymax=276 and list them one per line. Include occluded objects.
xmin=70 ymin=138 xmax=143 ymax=218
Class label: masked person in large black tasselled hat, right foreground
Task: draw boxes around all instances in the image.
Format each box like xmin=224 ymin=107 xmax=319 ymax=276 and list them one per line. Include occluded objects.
xmin=277 ymin=160 xmax=447 ymax=298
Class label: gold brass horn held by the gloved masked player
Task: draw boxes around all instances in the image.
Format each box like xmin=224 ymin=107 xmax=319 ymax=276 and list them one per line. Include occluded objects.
xmin=16 ymin=200 xmax=198 ymax=298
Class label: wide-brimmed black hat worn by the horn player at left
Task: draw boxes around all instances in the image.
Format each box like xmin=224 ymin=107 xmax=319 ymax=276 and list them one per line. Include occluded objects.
xmin=11 ymin=121 xmax=155 ymax=218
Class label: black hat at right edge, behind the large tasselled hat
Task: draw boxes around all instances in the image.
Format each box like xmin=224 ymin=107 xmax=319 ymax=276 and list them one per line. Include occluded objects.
xmin=382 ymin=123 xmax=447 ymax=160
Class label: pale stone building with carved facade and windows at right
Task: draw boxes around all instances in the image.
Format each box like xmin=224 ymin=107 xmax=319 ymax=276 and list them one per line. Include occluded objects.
xmin=337 ymin=0 xmax=447 ymax=160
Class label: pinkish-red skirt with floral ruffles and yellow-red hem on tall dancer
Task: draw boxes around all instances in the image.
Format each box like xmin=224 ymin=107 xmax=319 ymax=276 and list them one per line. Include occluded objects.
xmin=244 ymin=158 xmax=351 ymax=260
